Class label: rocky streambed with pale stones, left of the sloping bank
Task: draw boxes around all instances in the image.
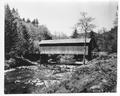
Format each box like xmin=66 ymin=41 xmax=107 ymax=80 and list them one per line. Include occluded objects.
xmin=5 ymin=65 xmax=76 ymax=94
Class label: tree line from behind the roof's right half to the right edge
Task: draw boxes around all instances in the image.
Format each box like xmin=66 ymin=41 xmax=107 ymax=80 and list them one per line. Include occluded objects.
xmin=71 ymin=20 xmax=118 ymax=53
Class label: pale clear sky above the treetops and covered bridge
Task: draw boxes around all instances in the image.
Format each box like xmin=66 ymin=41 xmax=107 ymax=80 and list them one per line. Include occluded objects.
xmin=5 ymin=0 xmax=117 ymax=36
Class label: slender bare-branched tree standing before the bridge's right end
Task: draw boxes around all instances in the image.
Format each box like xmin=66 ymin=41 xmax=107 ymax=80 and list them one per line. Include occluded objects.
xmin=77 ymin=12 xmax=95 ymax=64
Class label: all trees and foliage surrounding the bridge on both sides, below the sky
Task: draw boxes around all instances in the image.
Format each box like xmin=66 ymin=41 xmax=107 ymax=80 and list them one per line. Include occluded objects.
xmin=5 ymin=5 xmax=118 ymax=59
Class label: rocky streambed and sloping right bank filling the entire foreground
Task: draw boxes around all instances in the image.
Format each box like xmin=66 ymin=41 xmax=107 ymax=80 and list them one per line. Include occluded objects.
xmin=5 ymin=54 xmax=117 ymax=94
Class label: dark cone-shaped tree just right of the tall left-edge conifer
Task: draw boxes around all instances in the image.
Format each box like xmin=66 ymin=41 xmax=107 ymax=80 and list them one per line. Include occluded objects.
xmin=11 ymin=22 xmax=30 ymax=57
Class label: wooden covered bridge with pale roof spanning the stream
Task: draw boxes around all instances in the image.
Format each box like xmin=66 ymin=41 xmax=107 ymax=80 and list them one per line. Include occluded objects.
xmin=39 ymin=38 xmax=96 ymax=62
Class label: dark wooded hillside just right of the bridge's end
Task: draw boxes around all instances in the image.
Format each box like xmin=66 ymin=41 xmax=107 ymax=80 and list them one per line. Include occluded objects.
xmin=96 ymin=27 xmax=117 ymax=53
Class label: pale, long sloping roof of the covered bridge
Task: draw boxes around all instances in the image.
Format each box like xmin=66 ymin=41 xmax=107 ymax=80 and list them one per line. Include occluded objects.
xmin=39 ymin=38 xmax=91 ymax=44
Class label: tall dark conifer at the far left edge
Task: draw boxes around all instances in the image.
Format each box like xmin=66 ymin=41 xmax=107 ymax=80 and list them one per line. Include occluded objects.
xmin=5 ymin=5 xmax=17 ymax=56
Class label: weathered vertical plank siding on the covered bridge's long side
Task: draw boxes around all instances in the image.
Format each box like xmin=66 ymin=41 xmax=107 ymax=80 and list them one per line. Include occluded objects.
xmin=40 ymin=45 xmax=88 ymax=55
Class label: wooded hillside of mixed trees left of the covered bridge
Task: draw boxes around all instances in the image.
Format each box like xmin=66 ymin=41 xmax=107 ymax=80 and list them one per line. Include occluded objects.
xmin=5 ymin=5 xmax=52 ymax=59
